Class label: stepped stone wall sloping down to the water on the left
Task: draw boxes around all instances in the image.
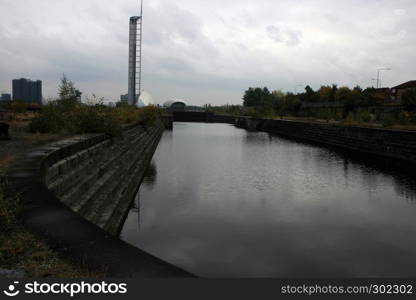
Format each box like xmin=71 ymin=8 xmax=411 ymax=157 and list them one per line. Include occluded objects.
xmin=42 ymin=122 xmax=164 ymax=235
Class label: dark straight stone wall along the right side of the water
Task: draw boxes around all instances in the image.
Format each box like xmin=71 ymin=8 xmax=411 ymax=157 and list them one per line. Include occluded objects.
xmin=236 ymin=117 xmax=416 ymax=163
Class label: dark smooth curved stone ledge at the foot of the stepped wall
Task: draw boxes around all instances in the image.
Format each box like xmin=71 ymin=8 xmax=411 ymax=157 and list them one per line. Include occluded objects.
xmin=21 ymin=184 xmax=195 ymax=278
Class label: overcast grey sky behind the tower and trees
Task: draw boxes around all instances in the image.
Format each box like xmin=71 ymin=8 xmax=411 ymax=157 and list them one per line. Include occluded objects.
xmin=0 ymin=0 xmax=416 ymax=105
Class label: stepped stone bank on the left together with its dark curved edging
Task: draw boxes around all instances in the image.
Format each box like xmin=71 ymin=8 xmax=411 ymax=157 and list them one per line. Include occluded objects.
xmin=2 ymin=120 xmax=193 ymax=277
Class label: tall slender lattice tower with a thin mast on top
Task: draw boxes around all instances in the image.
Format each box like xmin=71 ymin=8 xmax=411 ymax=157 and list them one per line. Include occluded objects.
xmin=128 ymin=1 xmax=143 ymax=105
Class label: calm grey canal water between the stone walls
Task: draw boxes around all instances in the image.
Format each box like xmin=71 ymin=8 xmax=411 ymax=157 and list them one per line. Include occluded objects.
xmin=121 ymin=123 xmax=416 ymax=278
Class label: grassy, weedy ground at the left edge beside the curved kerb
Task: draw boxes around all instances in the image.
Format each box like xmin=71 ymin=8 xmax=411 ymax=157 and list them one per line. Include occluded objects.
xmin=0 ymin=129 xmax=103 ymax=278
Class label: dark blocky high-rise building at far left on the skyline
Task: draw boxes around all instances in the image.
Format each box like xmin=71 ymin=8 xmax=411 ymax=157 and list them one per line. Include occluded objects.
xmin=13 ymin=78 xmax=42 ymax=104
